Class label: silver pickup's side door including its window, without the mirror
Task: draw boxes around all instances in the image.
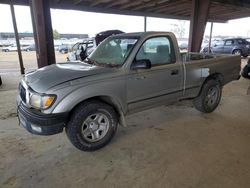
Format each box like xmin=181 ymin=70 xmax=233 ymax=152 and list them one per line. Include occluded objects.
xmin=127 ymin=36 xmax=182 ymax=112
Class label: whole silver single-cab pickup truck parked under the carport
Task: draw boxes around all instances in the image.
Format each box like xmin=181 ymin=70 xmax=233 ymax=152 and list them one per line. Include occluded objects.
xmin=17 ymin=32 xmax=241 ymax=151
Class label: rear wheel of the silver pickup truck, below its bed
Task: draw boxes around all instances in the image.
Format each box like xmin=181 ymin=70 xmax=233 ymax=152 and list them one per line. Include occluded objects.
xmin=193 ymin=79 xmax=222 ymax=113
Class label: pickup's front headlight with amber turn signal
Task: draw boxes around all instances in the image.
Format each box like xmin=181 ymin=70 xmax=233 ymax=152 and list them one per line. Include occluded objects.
xmin=30 ymin=93 xmax=56 ymax=110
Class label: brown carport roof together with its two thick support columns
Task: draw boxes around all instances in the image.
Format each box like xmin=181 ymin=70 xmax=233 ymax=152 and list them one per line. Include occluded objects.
xmin=0 ymin=0 xmax=250 ymax=70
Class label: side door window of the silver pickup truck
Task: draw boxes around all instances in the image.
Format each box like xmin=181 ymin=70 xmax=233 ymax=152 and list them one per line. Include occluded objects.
xmin=136 ymin=37 xmax=175 ymax=66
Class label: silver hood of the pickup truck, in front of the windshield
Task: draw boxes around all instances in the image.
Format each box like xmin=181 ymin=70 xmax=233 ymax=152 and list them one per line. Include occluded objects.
xmin=25 ymin=62 xmax=113 ymax=93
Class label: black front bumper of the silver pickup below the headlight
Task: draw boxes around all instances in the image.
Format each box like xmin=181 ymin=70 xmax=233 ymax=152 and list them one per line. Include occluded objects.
xmin=17 ymin=103 xmax=68 ymax=135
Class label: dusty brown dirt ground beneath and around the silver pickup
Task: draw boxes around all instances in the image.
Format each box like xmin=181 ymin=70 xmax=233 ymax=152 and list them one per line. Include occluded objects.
xmin=0 ymin=52 xmax=250 ymax=188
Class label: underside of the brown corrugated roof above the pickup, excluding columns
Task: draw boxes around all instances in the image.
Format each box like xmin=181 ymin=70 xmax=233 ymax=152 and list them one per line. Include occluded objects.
xmin=0 ymin=0 xmax=250 ymax=22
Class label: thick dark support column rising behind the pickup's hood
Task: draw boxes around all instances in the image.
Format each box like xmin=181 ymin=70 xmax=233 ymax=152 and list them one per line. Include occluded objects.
xmin=30 ymin=0 xmax=55 ymax=68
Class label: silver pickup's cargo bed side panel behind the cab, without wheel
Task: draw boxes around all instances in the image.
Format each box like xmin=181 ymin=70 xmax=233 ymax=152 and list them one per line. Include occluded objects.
xmin=181 ymin=53 xmax=241 ymax=98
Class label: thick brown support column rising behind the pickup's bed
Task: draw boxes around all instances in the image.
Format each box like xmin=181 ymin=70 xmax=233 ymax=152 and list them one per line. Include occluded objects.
xmin=188 ymin=0 xmax=210 ymax=52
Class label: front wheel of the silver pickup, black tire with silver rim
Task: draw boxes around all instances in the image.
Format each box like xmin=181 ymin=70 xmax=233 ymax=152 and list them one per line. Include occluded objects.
xmin=66 ymin=100 xmax=118 ymax=151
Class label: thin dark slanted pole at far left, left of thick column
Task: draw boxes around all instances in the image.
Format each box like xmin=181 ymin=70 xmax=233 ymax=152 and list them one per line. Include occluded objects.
xmin=10 ymin=2 xmax=24 ymax=74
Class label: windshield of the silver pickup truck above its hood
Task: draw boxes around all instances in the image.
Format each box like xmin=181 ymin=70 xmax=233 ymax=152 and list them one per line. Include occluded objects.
xmin=89 ymin=37 xmax=138 ymax=67
